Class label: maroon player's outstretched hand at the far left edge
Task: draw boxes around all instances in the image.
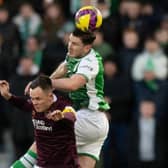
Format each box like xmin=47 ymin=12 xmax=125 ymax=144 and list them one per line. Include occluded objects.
xmin=0 ymin=80 xmax=12 ymax=100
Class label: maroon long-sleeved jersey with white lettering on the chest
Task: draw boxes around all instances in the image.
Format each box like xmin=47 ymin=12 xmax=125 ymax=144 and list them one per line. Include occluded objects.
xmin=10 ymin=96 xmax=79 ymax=168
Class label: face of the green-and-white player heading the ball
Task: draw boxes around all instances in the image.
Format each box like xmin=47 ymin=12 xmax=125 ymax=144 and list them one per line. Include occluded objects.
xmin=68 ymin=34 xmax=87 ymax=58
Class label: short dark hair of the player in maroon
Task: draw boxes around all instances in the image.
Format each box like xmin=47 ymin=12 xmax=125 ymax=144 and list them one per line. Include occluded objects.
xmin=30 ymin=75 xmax=52 ymax=90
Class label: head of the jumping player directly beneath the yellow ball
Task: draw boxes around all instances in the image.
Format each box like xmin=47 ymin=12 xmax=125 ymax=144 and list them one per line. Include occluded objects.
xmin=68 ymin=29 xmax=96 ymax=57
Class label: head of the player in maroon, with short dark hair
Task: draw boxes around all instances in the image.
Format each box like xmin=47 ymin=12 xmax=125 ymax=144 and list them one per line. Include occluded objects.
xmin=30 ymin=75 xmax=53 ymax=112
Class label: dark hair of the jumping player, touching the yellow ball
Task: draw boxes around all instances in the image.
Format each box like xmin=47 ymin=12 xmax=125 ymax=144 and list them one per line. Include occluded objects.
xmin=72 ymin=28 xmax=96 ymax=45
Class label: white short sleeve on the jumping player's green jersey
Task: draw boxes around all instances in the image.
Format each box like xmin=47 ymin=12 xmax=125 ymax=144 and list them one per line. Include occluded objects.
xmin=76 ymin=58 xmax=98 ymax=80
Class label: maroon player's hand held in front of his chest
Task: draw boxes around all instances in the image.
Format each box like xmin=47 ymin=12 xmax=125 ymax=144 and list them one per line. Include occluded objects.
xmin=46 ymin=110 xmax=64 ymax=121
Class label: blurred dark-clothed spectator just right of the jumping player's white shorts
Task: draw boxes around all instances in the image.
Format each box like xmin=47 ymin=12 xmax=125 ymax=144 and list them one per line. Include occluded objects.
xmin=102 ymin=58 xmax=132 ymax=168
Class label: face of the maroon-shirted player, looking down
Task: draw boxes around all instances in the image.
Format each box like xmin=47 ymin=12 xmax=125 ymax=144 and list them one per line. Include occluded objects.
xmin=30 ymin=87 xmax=53 ymax=112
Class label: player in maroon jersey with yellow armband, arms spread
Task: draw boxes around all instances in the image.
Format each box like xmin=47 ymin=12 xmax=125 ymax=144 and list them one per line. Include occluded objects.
xmin=0 ymin=75 xmax=79 ymax=168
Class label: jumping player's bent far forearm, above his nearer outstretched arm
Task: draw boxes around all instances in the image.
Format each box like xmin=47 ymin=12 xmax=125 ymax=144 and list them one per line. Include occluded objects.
xmin=50 ymin=61 xmax=67 ymax=79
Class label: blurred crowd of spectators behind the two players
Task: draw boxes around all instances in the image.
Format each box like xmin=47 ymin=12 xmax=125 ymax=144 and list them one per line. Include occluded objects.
xmin=0 ymin=0 xmax=168 ymax=168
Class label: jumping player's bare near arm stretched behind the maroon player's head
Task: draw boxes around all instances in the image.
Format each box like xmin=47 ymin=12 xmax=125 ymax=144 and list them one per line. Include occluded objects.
xmin=52 ymin=74 xmax=87 ymax=91
